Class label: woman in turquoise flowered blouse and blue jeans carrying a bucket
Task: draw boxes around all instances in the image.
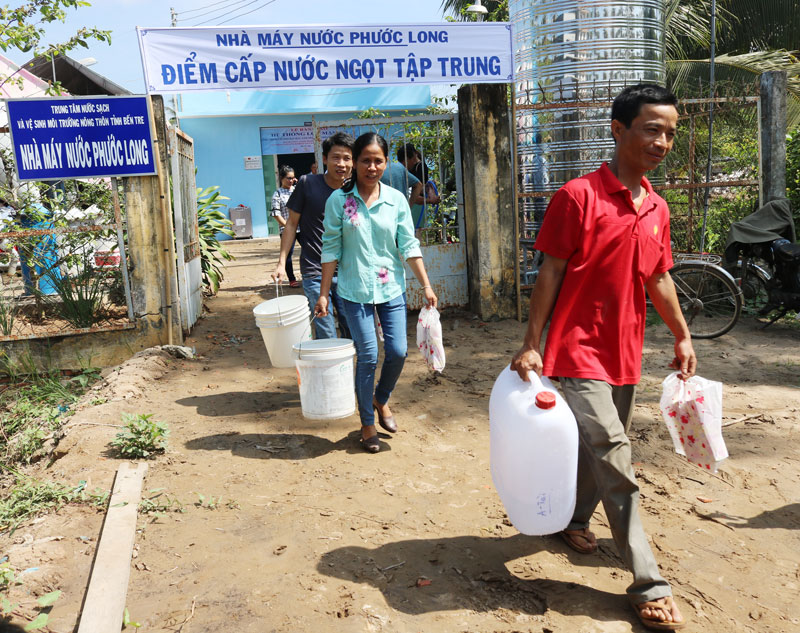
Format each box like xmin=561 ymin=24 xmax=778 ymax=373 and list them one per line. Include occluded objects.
xmin=314 ymin=132 xmax=437 ymax=453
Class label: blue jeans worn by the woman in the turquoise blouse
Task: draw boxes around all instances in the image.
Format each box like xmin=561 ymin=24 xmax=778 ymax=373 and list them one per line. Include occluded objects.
xmin=342 ymin=294 xmax=408 ymax=426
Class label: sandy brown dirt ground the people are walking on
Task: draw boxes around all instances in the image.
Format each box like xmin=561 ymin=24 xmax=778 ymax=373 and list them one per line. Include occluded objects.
xmin=0 ymin=240 xmax=800 ymax=633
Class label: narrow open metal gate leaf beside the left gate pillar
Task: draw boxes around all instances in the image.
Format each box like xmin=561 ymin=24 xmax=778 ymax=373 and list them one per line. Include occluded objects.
xmin=169 ymin=127 xmax=203 ymax=332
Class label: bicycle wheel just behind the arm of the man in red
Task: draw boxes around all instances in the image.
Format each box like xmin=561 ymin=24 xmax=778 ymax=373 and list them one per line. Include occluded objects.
xmin=670 ymin=262 xmax=742 ymax=338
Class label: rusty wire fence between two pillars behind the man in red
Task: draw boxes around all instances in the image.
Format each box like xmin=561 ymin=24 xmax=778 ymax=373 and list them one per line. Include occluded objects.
xmin=515 ymin=86 xmax=759 ymax=289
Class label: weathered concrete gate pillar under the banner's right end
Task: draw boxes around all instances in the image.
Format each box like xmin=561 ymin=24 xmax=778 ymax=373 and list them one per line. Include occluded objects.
xmin=458 ymin=84 xmax=517 ymax=321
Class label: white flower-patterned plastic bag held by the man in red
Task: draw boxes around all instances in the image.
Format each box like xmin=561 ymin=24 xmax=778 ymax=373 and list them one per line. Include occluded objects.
xmin=661 ymin=371 xmax=728 ymax=472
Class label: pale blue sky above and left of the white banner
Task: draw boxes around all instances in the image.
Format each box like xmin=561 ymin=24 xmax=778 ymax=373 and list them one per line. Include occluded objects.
xmin=4 ymin=0 xmax=460 ymax=94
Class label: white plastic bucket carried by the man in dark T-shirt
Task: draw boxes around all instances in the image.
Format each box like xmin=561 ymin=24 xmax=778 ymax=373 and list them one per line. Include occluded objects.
xmin=253 ymin=295 xmax=311 ymax=367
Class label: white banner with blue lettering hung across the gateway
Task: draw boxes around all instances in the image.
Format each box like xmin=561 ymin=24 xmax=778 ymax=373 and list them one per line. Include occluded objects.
xmin=137 ymin=22 xmax=513 ymax=93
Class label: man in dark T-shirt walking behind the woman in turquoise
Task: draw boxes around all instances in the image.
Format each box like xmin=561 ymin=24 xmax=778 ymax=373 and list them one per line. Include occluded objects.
xmin=272 ymin=132 xmax=355 ymax=339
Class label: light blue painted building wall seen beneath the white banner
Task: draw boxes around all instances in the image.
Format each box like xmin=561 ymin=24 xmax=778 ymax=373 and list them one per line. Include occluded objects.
xmin=178 ymin=86 xmax=431 ymax=237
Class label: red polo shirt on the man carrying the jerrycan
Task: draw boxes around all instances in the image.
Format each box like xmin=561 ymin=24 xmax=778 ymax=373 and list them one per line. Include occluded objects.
xmin=534 ymin=163 xmax=672 ymax=385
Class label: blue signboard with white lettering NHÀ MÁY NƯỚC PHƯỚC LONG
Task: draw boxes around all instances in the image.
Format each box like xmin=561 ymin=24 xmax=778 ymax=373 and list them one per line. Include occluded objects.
xmin=6 ymin=96 xmax=156 ymax=181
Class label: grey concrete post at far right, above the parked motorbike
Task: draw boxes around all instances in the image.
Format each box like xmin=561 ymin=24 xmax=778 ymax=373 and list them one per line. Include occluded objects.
xmin=759 ymin=70 xmax=786 ymax=205
